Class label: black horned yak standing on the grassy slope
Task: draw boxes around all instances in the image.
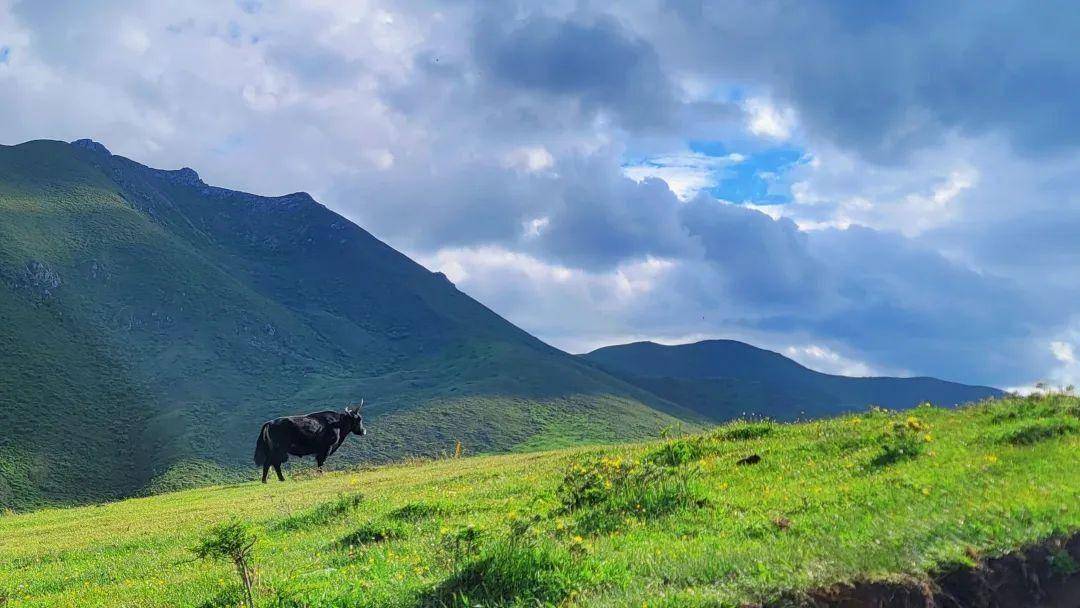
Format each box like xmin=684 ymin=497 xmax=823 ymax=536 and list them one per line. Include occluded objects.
xmin=255 ymin=400 xmax=367 ymax=484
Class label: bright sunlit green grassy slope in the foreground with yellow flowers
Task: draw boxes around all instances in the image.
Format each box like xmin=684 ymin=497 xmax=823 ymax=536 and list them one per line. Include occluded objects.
xmin=0 ymin=395 xmax=1080 ymax=607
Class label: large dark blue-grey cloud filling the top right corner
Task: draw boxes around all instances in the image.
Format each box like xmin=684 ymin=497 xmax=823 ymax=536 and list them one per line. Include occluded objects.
xmin=644 ymin=1 xmax=1080 ymax=161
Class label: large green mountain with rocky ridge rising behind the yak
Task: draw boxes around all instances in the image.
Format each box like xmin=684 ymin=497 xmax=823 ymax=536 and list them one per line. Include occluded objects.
xmin=0 ymin=139 xmax=700 ymax=508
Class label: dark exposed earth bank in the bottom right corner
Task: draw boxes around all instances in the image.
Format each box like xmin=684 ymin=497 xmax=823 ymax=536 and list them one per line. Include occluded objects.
xmin=773 ymin=533 xmax=1080 ymax=608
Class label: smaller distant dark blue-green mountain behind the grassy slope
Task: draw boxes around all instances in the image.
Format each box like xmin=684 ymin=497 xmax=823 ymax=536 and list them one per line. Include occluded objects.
xmin=581 ymin=340 xmax=1003 ymax=420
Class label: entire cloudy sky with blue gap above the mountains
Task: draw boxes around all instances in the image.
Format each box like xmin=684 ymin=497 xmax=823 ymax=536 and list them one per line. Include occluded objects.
xmin=0 ymin=0 xmax=1080 ymax=387
